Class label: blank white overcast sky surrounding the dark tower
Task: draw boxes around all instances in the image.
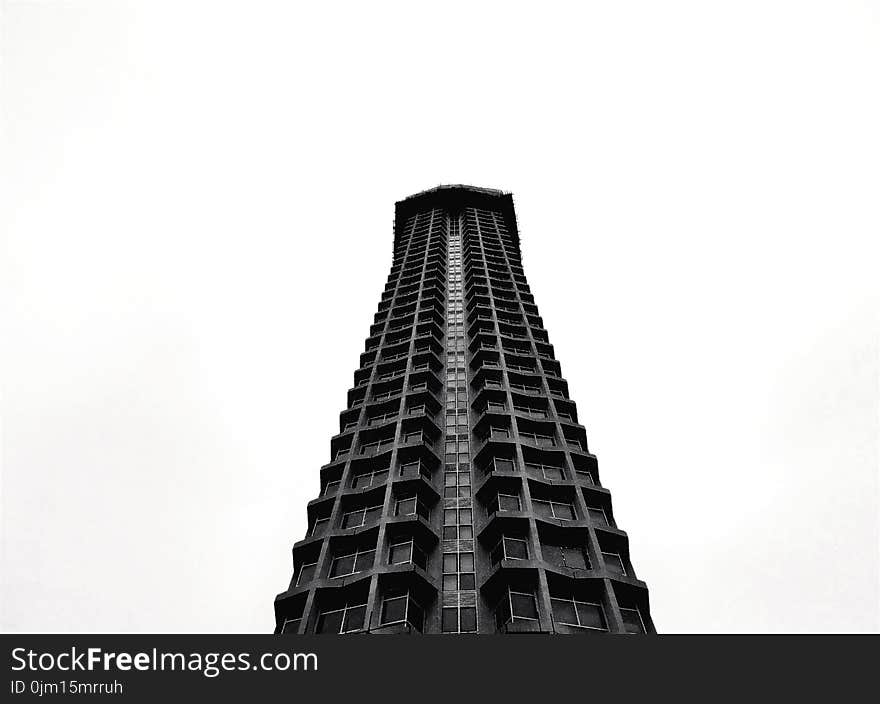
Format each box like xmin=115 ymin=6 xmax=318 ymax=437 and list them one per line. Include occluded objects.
xmin=0 ymin=0 xmax=880 ymax=632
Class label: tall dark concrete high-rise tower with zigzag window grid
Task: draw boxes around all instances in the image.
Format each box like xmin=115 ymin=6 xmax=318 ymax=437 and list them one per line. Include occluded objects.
xmin=275 ymin=186 xmax=654 ymax=633
